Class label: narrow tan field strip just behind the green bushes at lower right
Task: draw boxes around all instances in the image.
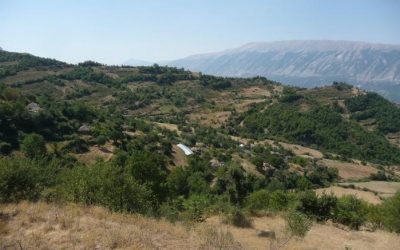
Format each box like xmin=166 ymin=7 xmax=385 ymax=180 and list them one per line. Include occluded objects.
xmin=316 ymin=186 xmax=382 ymax=204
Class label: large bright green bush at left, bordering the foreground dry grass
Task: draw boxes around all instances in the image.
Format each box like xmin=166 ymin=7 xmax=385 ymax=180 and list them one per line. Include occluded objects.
xmin=58 ymin=163 xmax=156 ymax=214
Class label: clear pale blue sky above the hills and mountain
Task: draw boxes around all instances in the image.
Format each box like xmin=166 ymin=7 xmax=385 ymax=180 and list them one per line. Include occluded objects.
xmin=0 ymin=0 xmax=400 ymax=64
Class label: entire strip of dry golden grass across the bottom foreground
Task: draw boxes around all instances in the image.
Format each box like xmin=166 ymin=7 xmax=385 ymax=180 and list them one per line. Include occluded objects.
xmin=0 ymin=202 xmax=400 ymax=250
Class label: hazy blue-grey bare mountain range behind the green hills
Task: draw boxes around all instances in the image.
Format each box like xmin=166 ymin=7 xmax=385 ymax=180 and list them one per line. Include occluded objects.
xmin=165 ymin=40 xmax=400 ymax=102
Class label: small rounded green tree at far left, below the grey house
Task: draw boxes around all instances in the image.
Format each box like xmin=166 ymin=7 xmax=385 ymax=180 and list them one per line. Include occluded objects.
xmin=21 ymin=133 xmax=46 ymax=159
